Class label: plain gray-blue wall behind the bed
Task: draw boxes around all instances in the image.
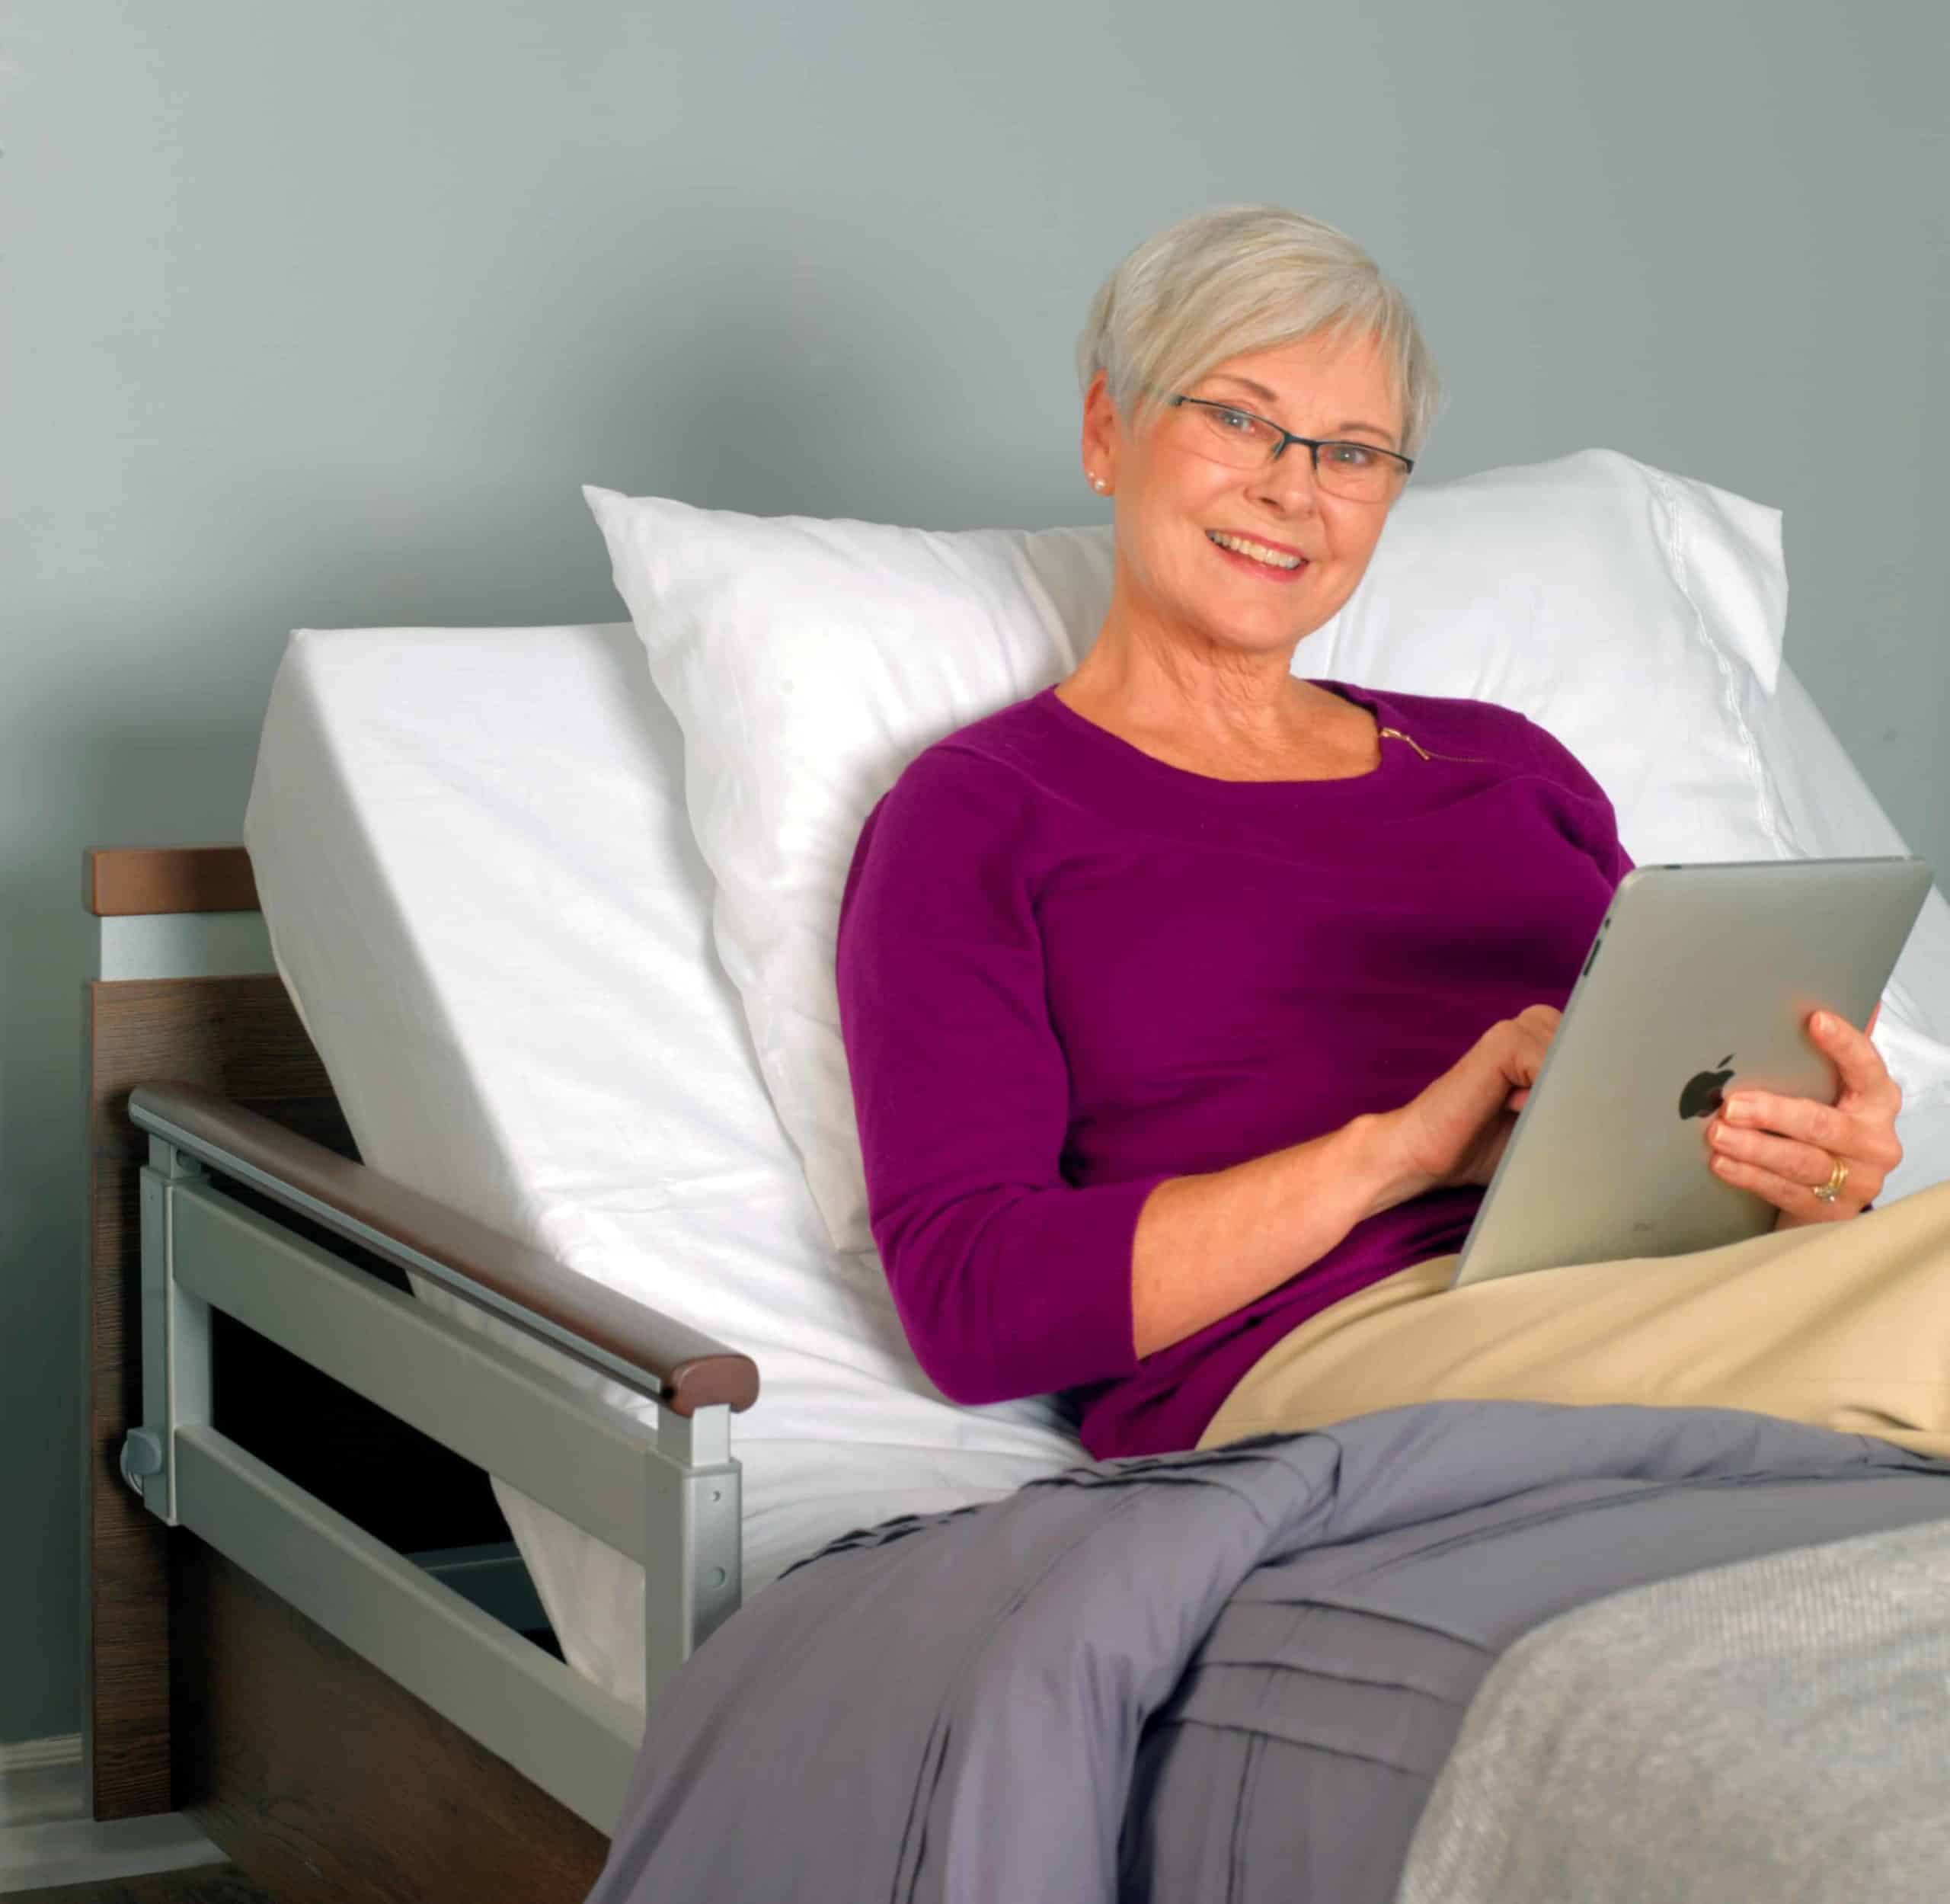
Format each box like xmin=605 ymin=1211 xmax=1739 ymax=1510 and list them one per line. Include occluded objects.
xmin=0 ymin=0 xmax=1950 ymax=1740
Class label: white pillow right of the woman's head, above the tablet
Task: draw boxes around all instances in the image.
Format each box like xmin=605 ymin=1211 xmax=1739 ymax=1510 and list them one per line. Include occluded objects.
xmin=1293 ymin=449 xmax=1792 ymax=862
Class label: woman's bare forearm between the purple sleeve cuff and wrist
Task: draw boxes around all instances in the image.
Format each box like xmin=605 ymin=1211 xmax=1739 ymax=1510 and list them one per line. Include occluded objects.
xmin=1131 ymin=1116 xmax=1418 ymax=1356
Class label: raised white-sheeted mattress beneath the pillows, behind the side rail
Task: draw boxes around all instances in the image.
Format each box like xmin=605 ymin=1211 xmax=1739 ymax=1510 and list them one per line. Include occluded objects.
xmin=244 ymin=622 xmax=1950 ymax=1703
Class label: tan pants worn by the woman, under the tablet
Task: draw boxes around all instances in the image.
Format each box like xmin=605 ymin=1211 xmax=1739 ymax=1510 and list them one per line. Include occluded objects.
xmin=1199 ymin=1182 xmax=1950 ymax=1458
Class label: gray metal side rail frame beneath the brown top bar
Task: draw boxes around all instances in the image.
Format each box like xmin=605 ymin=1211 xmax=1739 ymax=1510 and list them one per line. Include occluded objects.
xmin=121 ymin=1085 xmax=755 ymax=1834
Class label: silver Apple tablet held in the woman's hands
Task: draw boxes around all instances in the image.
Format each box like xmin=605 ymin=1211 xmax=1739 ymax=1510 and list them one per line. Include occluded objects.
xmin=1451 ymin=856 xmax=1930 ymax=1288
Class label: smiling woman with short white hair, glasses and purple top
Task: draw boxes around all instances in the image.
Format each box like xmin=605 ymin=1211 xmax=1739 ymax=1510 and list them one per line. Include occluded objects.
xmin=839 ymin=206 xmax=1950 ymax=1458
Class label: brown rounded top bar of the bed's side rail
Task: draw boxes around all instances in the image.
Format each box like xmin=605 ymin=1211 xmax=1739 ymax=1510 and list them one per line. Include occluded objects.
xmin=129 ymin=1080 xmax=759 ymax=1414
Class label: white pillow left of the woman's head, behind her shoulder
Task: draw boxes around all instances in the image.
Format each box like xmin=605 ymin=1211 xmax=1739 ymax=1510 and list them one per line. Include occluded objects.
xmin=583 ymin=488 xmax=1111 ymax=1274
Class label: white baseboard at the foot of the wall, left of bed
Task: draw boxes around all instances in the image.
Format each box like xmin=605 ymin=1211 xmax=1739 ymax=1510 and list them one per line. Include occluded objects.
xmin=0 ymin=1733 xmax=224 ymax=1896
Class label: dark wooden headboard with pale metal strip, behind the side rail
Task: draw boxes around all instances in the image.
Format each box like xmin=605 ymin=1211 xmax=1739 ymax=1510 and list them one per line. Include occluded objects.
xmin=82 ymin=846 xmax=349 ymax=1820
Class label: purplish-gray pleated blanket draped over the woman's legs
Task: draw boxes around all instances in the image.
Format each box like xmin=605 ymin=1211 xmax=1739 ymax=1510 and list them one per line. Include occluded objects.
xmin=591 ymin=1403 xmax=1950 ymax=1904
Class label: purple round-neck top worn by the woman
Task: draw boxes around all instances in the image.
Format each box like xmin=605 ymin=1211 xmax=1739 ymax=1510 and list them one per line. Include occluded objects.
xmin=836 ymin=681 xmax=1632 ymax=1459
